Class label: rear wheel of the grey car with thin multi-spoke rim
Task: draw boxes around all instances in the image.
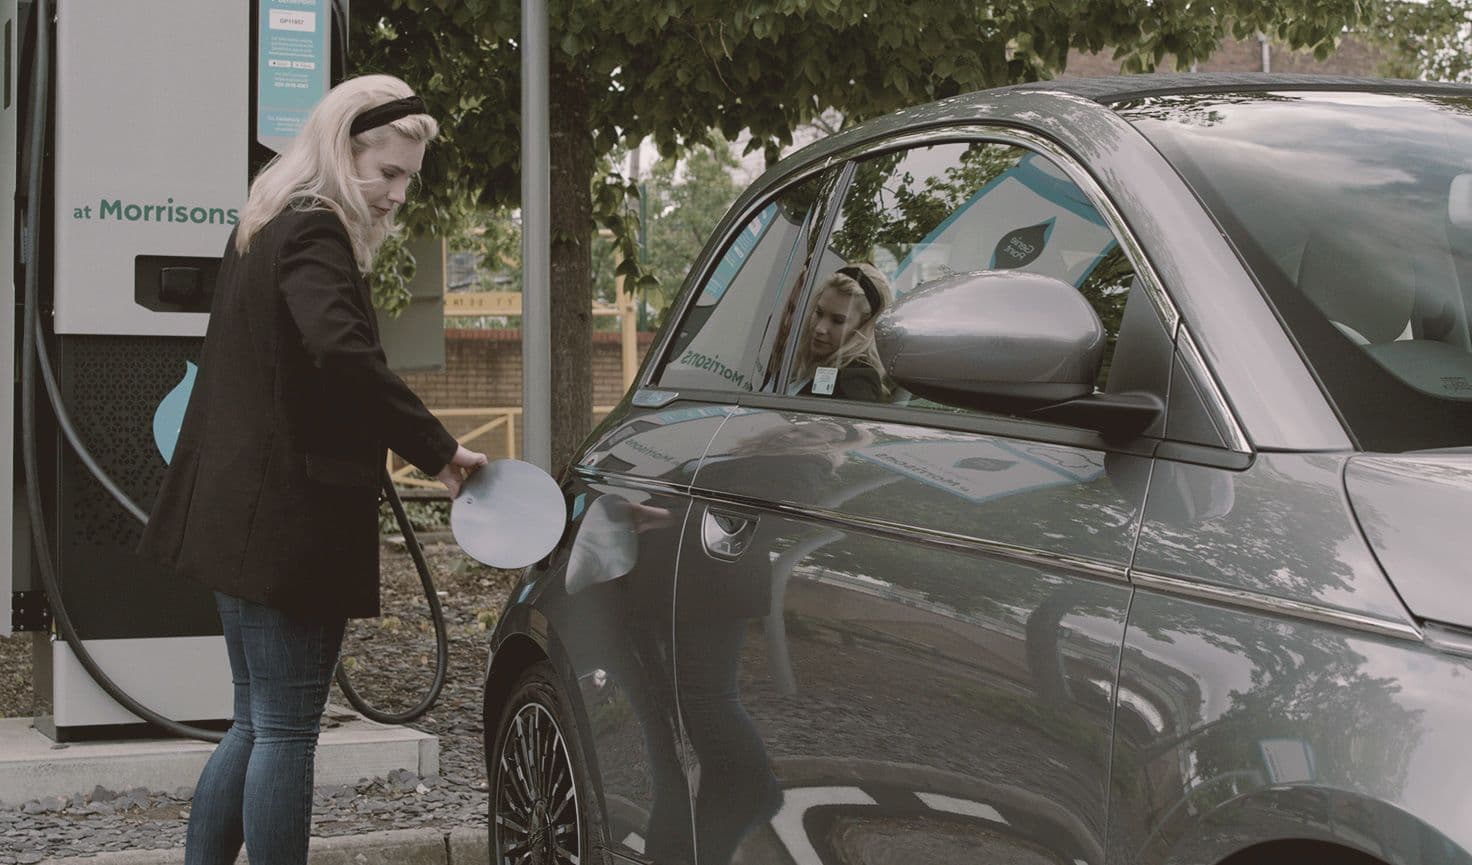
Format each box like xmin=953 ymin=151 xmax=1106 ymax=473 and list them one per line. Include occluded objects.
xmin=487 ymin=662 xmax=601 ymax=865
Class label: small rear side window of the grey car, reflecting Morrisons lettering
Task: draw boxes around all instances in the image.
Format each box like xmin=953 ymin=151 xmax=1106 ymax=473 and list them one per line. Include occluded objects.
xmin=657 ymin=175 xmax=829 ymax=391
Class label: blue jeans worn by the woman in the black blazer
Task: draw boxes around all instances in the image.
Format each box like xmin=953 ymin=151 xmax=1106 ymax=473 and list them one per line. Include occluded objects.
xmin=184 ymin=591 xmax=346 ymax=865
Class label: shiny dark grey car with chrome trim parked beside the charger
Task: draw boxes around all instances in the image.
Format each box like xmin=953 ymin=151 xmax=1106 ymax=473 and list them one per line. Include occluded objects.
xmin=486 ymin=75 xmax=1472 ymax=865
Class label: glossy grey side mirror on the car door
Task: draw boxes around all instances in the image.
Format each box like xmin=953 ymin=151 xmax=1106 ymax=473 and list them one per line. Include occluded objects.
xmin=874 ymin=271 xmax=1164 ymax=438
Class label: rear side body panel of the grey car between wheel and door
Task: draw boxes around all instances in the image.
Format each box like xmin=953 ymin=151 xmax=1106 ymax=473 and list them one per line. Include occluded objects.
xmin=536 ymin=400 xmax=724 ymax=861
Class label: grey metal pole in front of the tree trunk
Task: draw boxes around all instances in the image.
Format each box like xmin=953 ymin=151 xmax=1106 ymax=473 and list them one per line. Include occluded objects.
xmin=521 ymin=0 xmax=552 ymax=471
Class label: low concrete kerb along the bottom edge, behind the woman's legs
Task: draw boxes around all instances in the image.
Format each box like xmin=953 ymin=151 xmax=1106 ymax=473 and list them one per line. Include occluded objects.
xmin=37 ymin=828 xmax=490 ymax=865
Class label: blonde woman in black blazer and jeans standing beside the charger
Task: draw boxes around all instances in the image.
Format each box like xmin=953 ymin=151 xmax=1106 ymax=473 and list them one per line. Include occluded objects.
xmin=140 ymin=75 xmax=486 ymax=865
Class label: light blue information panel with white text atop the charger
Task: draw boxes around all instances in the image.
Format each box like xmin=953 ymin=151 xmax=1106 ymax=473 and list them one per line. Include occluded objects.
xmin=256 ymin=0 xmax=331 ymax=152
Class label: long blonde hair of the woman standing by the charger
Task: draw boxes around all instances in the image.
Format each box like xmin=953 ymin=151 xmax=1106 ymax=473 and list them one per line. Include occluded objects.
xmin=236 ymin=75 xmax=440 ymax=272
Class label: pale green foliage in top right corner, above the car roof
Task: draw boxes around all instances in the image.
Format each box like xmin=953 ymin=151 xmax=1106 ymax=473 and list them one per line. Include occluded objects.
xmin=1365 ymin=0 xmax=1472 ymax=81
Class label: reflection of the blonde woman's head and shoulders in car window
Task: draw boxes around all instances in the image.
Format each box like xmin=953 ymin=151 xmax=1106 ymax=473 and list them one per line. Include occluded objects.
xmin=788 ymin=263 xmax=894 ymax=402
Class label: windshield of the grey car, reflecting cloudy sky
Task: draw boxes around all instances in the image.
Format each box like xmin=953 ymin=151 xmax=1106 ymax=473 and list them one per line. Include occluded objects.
xmin=1114 ymin=91 xmax=1472 ymax=452
